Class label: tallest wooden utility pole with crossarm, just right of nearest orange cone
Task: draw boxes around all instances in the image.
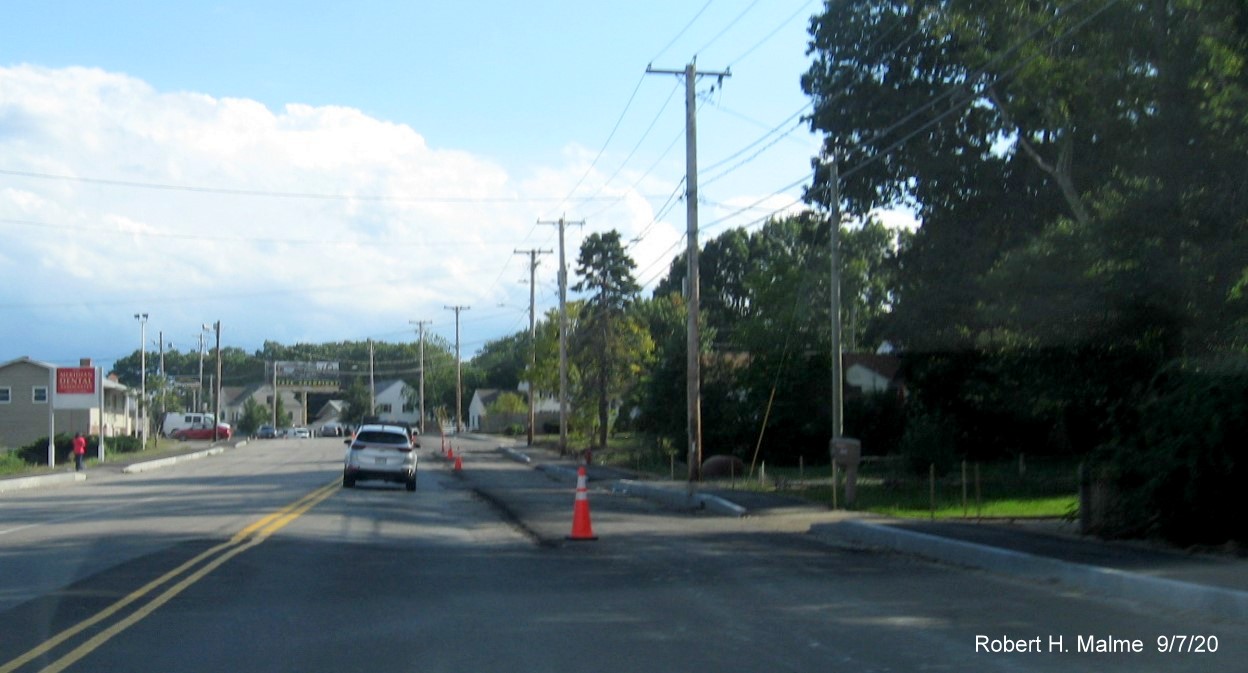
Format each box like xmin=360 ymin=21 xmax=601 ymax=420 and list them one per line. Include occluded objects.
xmin=645 ymin=60 xmax=733 ymax=482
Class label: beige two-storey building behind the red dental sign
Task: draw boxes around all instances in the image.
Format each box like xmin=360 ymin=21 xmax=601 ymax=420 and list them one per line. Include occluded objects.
xmin=0 ymin=357 xmax=137 ymax=448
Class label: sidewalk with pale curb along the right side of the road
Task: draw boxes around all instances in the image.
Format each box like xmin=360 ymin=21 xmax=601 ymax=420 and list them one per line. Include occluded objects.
xmin=486 ymin=447 xmax=1248 ymax=622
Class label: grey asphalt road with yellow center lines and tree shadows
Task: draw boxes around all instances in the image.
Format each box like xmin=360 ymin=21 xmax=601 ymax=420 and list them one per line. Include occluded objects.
xmin=0 ymin=440 xmax=1248 ymax=673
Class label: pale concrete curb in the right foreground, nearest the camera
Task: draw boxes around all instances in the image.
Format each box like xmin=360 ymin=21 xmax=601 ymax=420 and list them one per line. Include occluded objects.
xmin=810 ymin=521 xmax=1248 ymax=621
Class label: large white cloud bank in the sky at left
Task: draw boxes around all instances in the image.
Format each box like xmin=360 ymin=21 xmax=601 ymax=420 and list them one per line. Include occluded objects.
xmin=0 ymin=66 xmax=683 ymax=361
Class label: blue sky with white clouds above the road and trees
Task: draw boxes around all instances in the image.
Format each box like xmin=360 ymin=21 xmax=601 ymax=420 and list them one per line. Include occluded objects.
xmin=0 ymin=0 xmax=838 ymax=366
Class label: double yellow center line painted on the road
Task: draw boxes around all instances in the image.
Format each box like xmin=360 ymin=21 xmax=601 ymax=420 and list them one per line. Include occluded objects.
xmin=0 ymin=478 xmax=341 ymax=673
